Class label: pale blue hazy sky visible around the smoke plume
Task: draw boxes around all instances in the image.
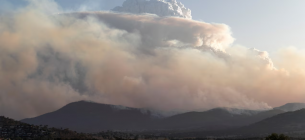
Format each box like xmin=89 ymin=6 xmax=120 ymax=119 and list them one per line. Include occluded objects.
xmin=0 ymin=0 xmax=305 ymax=52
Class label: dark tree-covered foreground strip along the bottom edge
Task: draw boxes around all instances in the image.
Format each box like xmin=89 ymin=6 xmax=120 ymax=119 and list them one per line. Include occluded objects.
xmin=0 ymin=116 xmax=305 ymax=140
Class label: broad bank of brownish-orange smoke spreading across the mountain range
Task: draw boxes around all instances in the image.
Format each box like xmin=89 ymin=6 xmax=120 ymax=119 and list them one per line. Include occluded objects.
xmin=0 ymin=1 xmax=305 ymax=119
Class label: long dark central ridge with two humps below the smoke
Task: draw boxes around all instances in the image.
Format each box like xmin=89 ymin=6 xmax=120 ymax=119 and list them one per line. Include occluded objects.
xmin=22 ymin=101 xmax=284 ymax=132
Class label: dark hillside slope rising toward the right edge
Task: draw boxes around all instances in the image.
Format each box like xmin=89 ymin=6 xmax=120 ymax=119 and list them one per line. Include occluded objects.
xmin=164 ymin=109 xmax=305 ymax=138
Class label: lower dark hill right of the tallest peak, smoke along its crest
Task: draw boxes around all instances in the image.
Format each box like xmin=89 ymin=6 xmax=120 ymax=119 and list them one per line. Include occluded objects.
xmin=159 ymin=108 xmax=284 ymax=131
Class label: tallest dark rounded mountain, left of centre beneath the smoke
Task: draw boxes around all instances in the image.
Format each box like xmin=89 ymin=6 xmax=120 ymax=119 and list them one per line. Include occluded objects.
xmin=21 ymin=101 xmax=156 ymax=132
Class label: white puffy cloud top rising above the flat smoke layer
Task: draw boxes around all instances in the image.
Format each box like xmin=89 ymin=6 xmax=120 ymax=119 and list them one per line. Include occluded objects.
xmin=113 ymin=0 xmax=192 ymax=19
